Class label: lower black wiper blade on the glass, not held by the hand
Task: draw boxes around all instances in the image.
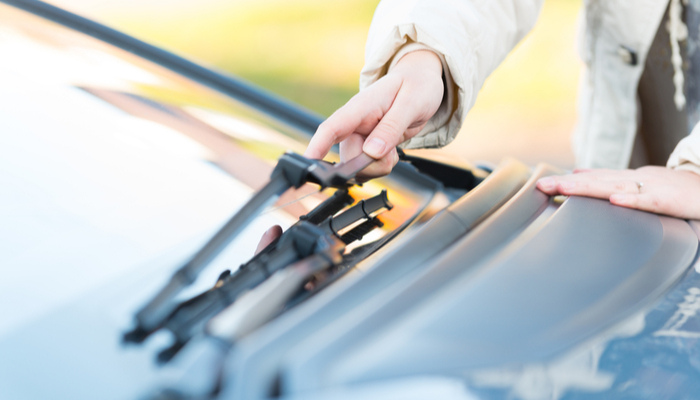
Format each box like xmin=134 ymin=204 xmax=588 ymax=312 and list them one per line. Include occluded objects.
xmin=158 ymin=190 xmax=393 ymax=362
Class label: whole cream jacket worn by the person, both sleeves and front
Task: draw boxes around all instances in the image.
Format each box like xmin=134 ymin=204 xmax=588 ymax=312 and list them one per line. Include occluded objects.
xmin=360 ymin=0 xmax=700 ymax=173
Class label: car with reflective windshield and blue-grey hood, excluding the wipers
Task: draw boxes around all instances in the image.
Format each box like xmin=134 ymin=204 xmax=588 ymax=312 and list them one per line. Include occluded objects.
xmin=0 ymin=0 xmax=700 ymax=400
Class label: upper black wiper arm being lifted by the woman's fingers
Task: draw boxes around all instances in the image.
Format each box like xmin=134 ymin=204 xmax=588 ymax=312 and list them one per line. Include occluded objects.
xmin=123 ymin=153 xmax=374 ymax=343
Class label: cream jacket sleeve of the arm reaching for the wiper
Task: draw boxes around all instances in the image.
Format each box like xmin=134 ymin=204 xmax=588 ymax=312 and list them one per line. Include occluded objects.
xmin=360 ymin=0 xmax=543 ymax=148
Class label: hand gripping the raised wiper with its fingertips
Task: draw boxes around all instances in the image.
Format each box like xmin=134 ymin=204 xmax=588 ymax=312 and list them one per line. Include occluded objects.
xmin=304 ymin=50 xmax=444 ymax=179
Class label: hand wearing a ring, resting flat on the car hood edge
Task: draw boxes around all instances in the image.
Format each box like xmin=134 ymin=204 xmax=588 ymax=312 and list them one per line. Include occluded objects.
xmin=537 ymin=166 xmax=700 ymax=219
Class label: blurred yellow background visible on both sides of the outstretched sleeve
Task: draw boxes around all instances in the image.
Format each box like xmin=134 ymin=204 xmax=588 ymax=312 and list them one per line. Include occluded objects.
xmin=50 ymin=0 xmax=581 ymax=168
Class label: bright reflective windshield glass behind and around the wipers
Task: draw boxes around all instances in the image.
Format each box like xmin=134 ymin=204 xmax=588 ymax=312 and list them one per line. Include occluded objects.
xmin=0 ymin=1 xmax=433 ymax=344
